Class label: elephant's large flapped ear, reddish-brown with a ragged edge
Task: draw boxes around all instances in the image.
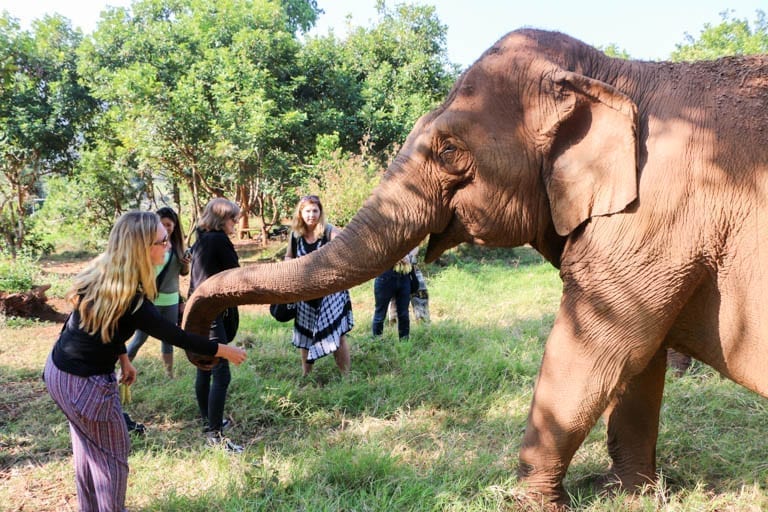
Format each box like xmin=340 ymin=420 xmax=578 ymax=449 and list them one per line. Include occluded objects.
xmin=543 ymin=71 xmax=639 ymax=236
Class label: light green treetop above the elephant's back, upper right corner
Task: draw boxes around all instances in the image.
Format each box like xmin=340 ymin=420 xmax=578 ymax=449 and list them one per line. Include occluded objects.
xmin=671 ymin=11 xmax=768 ymax=61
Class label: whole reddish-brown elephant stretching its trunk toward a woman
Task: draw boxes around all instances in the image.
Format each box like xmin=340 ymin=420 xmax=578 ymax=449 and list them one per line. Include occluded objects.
xmin=184 ymin=28 xmax=768 ymax=506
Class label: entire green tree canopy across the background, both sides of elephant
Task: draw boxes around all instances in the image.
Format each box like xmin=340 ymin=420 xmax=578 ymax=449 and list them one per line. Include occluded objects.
xmin=6 ymin=0 xmax=768 ymax=254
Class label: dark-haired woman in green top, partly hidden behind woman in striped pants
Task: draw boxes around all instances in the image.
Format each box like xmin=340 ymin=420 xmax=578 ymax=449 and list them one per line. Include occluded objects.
xmin=128 ymin=206 xmax=189 ymax=378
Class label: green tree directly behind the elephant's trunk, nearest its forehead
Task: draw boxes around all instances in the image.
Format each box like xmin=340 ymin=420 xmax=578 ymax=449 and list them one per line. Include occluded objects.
xmin=297 ymin=2 xmax=458 ymax=225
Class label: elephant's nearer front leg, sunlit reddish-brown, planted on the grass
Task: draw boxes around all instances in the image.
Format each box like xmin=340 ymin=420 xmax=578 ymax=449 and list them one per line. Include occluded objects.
xmin=519 ymin=314 xmax=661 ymax=503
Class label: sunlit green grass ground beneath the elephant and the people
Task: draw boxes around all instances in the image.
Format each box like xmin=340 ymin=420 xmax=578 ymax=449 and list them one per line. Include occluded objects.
xmin=0 ymin=246 xmax=768 ymax=512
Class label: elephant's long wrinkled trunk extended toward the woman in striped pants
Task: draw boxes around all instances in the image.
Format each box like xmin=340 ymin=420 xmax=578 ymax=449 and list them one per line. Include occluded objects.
xmin=184 ymin=162 xmax=450 ymax=334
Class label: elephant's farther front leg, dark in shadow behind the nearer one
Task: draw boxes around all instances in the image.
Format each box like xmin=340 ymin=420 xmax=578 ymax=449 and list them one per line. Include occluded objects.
xmin=605 ymin=349 xmax=667 ymax=490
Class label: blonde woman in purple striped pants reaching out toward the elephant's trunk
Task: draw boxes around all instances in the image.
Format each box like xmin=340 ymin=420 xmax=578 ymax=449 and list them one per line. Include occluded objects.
xmin=44 ymin=212 xmax=246 ymax=512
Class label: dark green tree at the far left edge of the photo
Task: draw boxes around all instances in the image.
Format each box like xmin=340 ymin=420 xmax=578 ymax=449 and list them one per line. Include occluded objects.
xmin=0 ymin=14 xmax=96 ymax=255
